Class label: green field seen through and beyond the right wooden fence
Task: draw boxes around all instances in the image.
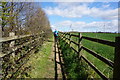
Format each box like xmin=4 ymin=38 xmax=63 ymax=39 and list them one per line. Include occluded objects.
xmin=61 ymin=33 xmax=118 ymax=78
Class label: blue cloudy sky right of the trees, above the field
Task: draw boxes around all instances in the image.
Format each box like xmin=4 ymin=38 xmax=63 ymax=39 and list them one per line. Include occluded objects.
xmin=41 ymin=2 xmax=118 ymax=32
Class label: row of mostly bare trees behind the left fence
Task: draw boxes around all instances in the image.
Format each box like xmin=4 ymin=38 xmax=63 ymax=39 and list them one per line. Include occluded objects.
xmin=0 ymin=2 xmax=51 ymax=37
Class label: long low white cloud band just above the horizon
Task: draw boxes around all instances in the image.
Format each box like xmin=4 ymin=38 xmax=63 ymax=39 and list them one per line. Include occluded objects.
xmin=53 ymin=20 xmax=118 ymax=32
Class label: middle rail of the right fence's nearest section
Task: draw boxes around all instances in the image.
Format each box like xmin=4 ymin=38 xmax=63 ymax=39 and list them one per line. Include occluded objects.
xmin=82 ymin=46 xmax=114 ymax=68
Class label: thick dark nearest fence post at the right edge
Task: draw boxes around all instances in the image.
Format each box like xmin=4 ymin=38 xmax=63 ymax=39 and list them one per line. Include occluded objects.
xmin=113 ymin=37 xmax=120 ymax=80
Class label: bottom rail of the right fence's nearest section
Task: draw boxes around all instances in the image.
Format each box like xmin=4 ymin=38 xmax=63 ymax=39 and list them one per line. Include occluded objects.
xmin=81 ymin=56 xmax=109 ymax=80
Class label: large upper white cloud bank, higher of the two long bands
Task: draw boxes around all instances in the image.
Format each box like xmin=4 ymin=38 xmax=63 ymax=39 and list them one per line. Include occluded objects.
xmin=44 ymin=3 xmax=118 ymax=20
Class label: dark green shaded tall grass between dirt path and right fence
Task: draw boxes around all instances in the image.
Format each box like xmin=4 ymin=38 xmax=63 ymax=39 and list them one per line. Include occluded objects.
xmin=59 ymin=38 xmax=88 ymax=80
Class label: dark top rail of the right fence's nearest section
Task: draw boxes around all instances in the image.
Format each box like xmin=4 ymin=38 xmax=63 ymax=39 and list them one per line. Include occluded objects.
xmin=82 ymin=36 xmax=115 ymax=47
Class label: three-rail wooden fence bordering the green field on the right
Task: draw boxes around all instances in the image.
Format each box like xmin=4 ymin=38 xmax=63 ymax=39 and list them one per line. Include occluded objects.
xmin=59 ymin=32 xmax=120 ymax=80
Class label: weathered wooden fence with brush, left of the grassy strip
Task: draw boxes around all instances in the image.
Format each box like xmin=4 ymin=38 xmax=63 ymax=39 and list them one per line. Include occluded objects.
xmin=0 ymin=33 xmax=45 ymax=79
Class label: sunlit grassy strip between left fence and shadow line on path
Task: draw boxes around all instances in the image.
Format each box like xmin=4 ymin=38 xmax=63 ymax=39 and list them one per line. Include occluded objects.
xmin=24 ymin=37 xmax=54 ymax=78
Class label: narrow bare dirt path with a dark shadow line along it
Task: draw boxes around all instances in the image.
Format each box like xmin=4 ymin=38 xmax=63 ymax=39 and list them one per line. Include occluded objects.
xmin=44 ymin=38 xmax=62 ymax=79
